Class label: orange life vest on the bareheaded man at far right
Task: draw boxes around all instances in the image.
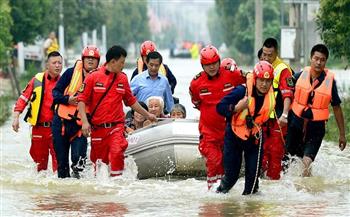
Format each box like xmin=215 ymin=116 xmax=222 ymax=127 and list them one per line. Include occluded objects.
xmin=292 ymin=67 xmax=334 ymax=121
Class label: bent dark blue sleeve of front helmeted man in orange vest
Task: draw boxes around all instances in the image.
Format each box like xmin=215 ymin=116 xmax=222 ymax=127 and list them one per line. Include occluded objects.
xmin=216 ymin=85 xmax=246 ymax=118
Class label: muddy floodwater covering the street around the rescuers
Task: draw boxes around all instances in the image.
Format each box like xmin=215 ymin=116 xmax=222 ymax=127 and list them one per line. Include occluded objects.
xmin=0 ymin=54 xmax=350 ymax=217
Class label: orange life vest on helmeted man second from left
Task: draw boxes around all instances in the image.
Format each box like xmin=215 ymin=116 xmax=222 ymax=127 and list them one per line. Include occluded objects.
xmin=57 ymin=60 xmax=88 ymax=125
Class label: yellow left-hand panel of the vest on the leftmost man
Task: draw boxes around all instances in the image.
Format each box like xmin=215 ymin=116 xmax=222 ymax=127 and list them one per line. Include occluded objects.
xmin=24 ymin=72 xmax=45 ymax=126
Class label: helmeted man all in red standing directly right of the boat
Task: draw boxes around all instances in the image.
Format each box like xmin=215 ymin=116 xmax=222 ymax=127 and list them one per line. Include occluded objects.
xmin=189 ymin=45 xmax=245 ymax=190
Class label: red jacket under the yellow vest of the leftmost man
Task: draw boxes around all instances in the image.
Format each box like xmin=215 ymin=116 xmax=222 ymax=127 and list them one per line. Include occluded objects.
xmin=13 ymin=72 xmax=59 ymax=123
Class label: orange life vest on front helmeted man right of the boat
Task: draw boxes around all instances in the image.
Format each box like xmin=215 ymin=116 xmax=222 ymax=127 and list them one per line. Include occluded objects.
xmin=231 ymin=73 xmax=276 ymax=140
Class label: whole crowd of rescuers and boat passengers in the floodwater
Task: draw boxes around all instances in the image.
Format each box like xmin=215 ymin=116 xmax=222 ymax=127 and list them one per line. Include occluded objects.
xmin=12 ymin=38 xmax=347 ymax=195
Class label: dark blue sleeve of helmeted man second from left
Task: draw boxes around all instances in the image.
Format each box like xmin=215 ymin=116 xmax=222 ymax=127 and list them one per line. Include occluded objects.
xmin=52 ymin=68 xmax=73 ymax=105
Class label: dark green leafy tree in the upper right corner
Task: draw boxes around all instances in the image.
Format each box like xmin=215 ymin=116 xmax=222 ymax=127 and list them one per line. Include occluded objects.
xmin=316 ymin=0 xmax=350 ymax=60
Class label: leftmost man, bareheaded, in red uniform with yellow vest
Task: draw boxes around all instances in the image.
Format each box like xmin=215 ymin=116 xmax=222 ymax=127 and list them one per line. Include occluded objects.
xmin=12 ymin=51 xmax=62 ymax=172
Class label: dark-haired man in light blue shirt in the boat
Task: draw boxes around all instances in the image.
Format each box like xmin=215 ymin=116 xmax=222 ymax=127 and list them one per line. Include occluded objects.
xmin=130 ymin=51 xmax=174 ymax=113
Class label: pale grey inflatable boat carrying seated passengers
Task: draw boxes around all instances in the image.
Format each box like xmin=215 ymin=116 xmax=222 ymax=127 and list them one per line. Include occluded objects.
xmin=125 ymin=118 xmax=206 ymax=179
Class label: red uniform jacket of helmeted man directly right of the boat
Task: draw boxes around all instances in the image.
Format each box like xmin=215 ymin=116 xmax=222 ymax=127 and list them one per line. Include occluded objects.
xmin=190 ymin=67 xmax=245 ymax=140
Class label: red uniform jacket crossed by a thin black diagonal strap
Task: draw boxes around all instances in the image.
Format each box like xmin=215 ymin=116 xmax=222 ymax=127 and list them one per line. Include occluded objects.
xmin=78 ymin=66 xmax=136 ymax=125
